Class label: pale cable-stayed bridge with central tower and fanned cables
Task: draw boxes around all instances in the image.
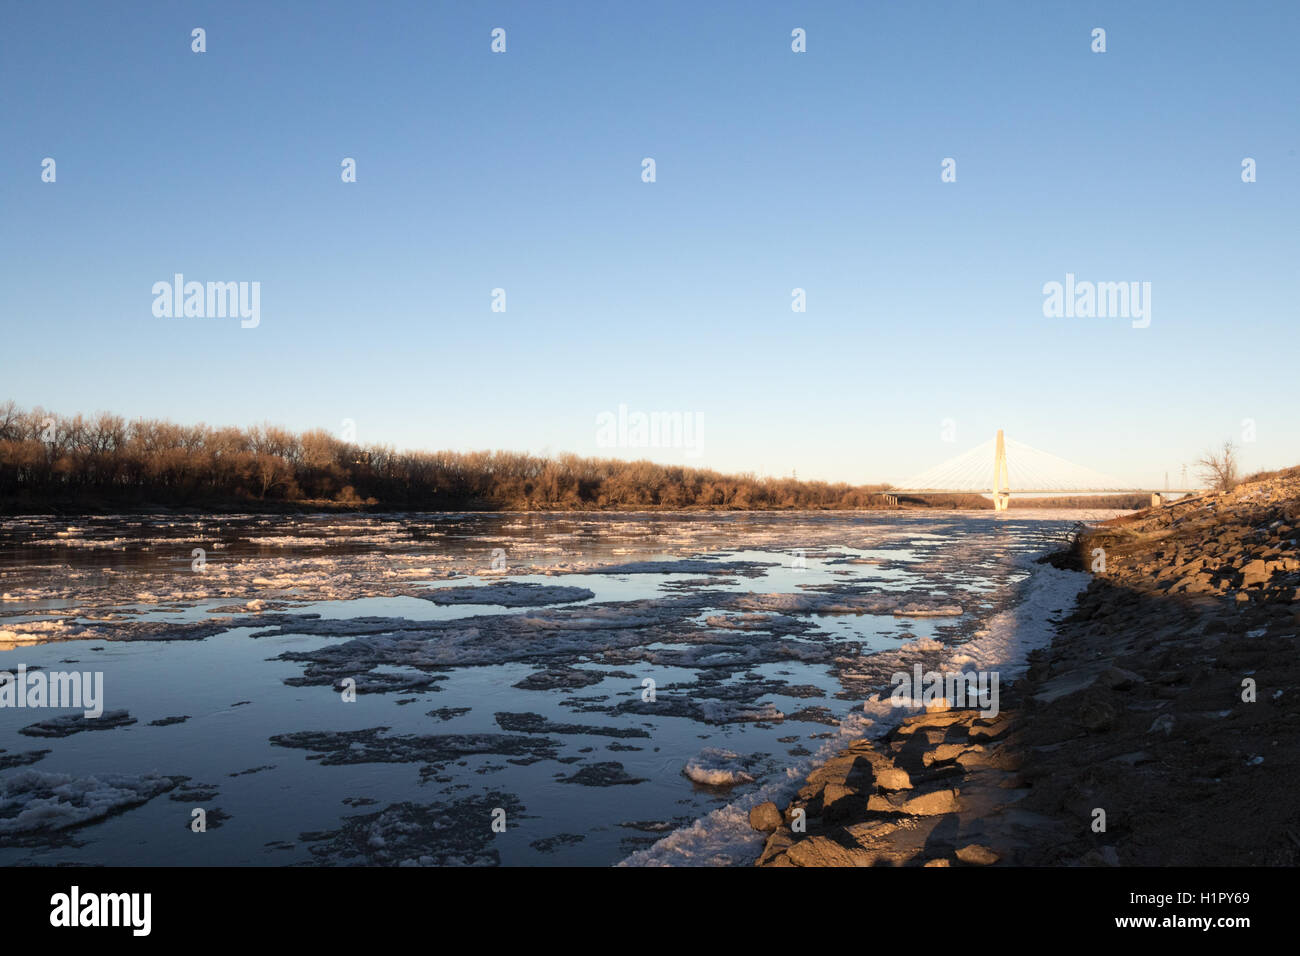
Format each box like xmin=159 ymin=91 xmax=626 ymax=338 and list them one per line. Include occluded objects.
xmin=891 ymin=431 xmax=1191 ymax=511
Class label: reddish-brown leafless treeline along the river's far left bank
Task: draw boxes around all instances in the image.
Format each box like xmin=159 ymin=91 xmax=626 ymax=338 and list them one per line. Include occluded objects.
xmin=0 ymin=402 xmax=915 ymax=512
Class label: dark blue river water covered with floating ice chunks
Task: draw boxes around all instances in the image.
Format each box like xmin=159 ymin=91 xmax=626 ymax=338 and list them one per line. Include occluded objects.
xmin=0 ymin=511 xmax=1109 ymax=865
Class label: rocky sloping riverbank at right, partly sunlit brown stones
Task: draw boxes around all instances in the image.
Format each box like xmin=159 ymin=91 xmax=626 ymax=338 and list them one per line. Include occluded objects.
xmin=750 ymin=470 xmax=1300 ymax=866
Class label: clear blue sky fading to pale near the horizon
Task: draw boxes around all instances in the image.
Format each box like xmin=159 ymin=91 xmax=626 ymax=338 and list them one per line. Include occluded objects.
xmin=0 ymin=3 xmax=1300 ymax=484
